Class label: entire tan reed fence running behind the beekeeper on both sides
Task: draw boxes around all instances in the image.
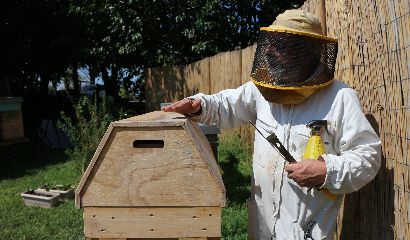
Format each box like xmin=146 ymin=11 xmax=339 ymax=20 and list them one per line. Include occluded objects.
xmin=146 ymin=0 xmax=410 ymax=240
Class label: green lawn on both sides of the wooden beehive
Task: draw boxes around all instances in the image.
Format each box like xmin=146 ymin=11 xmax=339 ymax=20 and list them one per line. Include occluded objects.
xmin=0 ymin=135 xmax=251 ymax=240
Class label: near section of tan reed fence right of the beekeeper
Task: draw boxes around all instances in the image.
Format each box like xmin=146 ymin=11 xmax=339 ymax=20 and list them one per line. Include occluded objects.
xmin=302 ymin=0 xmax=410 ymax=240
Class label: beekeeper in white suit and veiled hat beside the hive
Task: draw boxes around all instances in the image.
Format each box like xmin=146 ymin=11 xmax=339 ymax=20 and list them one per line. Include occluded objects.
xmin=163 ymin=10 xmax=381 ymax=240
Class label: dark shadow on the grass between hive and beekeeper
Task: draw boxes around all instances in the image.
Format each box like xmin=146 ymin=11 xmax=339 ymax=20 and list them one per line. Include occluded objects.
xmin=219 ymin=153 xmax=251 ymax=204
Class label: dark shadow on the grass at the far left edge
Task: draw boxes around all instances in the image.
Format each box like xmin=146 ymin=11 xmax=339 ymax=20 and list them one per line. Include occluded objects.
xmin=0 ymin=141 xmax=68 ymax=180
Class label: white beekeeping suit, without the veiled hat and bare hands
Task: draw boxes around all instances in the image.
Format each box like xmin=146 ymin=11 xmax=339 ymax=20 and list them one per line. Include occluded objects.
xmin=193 ymin=80 xmax=380 ymax=240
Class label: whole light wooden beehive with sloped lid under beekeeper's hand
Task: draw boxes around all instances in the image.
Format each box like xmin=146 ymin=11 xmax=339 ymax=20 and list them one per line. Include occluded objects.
xmin=76 ymin=112 xmax=225 ymax=239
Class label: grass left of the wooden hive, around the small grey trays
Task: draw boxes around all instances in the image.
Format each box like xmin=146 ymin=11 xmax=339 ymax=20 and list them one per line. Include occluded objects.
xmin=0 ymin=143 xmax=84 ymax=240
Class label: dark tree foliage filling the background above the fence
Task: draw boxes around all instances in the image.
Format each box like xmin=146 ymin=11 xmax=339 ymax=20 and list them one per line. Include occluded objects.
xmin=0 ymin=0 xmax=304 ymax=97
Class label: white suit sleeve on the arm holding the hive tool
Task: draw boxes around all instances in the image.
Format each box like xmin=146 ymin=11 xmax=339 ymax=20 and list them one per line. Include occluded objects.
xmin=322 ymin=89 xmax=381 ymax=194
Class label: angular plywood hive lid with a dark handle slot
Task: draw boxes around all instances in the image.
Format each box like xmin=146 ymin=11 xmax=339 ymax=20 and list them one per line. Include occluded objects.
xmin=76 ymin=111 xmax=225 ymax=208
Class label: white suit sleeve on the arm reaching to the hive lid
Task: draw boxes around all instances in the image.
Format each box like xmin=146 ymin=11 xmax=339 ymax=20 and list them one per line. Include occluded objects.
xmin=191 ymin=82 xmax=259 ymax=128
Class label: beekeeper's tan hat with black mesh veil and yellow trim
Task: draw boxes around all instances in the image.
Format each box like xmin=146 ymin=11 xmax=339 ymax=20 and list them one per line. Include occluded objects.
xmin=251 ymin=10 xmax=337 ymax=103
